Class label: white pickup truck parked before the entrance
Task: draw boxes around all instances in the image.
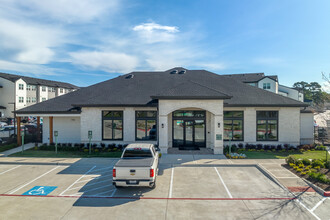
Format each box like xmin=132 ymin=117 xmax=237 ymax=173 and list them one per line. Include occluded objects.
xmin=112 ymin=144 xmax=159 ymax=188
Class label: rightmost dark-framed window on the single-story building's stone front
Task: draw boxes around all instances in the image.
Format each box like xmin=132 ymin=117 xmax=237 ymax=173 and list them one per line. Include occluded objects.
xmin=257 ymin=111 xmax=278 ymax=141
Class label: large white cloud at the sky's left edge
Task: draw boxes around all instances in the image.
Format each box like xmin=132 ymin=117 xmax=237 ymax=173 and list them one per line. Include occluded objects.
xmin=0 ymin=19 xmax=65 ymax=64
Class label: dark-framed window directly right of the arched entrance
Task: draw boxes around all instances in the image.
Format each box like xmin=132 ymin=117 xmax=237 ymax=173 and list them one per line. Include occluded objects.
xmin=223 ymin=111 xmax=244 ymax=141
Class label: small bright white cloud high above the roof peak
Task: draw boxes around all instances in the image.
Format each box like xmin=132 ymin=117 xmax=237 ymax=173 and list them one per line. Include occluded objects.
xmin=133 ymin=22 xmax=179 ymax=44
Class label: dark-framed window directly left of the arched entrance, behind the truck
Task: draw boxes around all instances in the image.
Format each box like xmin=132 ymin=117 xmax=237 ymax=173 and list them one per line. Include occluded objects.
xmin=135 ymin=111 xmax=157 ymax=140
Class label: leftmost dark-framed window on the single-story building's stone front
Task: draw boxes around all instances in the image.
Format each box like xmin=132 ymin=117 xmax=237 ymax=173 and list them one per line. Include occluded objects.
xmin=102 ymin=111 xmax=123 ymax=140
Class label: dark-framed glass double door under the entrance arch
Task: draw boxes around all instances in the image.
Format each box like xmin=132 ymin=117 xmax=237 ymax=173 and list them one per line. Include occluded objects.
xmin=173 ymin=119 xmax=205 ymax=147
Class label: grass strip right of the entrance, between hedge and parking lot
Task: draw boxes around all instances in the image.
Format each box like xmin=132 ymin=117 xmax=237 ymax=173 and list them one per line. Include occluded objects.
xmin=241 ymin=151 xmax=330 ymax=160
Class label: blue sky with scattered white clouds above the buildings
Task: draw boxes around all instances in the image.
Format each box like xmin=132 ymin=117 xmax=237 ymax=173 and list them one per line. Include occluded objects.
xmin=0 ymin=0 xmax=330 ymax=91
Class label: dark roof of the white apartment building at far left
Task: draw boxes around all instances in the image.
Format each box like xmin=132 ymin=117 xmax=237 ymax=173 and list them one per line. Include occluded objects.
xmin=0 ymin=73 xmax=79 ymax=89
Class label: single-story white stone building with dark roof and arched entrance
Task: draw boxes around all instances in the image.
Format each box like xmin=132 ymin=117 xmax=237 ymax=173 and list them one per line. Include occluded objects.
xmin=16 ymin=67 xmax=313 ymax=154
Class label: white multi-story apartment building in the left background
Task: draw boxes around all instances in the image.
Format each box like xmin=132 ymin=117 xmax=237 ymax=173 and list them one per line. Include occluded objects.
xmin=0 ymin=73 xmax=79 ymax=118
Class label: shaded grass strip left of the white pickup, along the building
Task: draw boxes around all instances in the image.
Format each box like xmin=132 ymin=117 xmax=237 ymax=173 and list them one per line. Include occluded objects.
xmin=9 ymin=149 xmax=122 ymax=158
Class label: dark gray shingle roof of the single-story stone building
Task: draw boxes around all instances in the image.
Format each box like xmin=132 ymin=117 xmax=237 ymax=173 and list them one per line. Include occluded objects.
xmin=17 ymin=68 xmax=306 ymax=113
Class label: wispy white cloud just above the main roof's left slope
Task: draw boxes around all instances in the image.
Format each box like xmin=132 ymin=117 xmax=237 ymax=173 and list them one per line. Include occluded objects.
xmin=70 ymin=51 xmax=138 ymax=73
